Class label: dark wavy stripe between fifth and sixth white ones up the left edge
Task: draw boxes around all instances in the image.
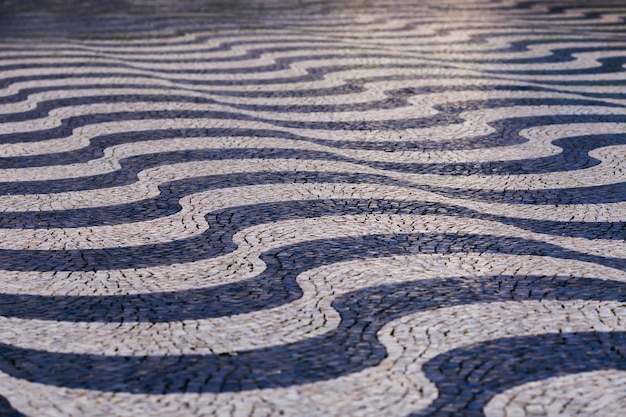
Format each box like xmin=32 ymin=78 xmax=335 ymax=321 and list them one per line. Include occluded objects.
xmin=0 ymin=140 xmax=626 ymax=195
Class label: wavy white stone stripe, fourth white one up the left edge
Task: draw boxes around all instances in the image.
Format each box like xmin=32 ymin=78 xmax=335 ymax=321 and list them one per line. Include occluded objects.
xmin=0 ymin=185 xmax=626 ymax=257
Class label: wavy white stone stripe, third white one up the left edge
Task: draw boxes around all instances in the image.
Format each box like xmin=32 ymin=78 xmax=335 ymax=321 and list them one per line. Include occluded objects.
xmin=1 ymin=210 xmax=626 ymax=295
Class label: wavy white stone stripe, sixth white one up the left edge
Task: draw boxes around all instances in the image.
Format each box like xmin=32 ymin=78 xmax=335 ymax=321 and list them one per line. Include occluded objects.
xmin=6 ymin=119 xmax=626 ymax=182
